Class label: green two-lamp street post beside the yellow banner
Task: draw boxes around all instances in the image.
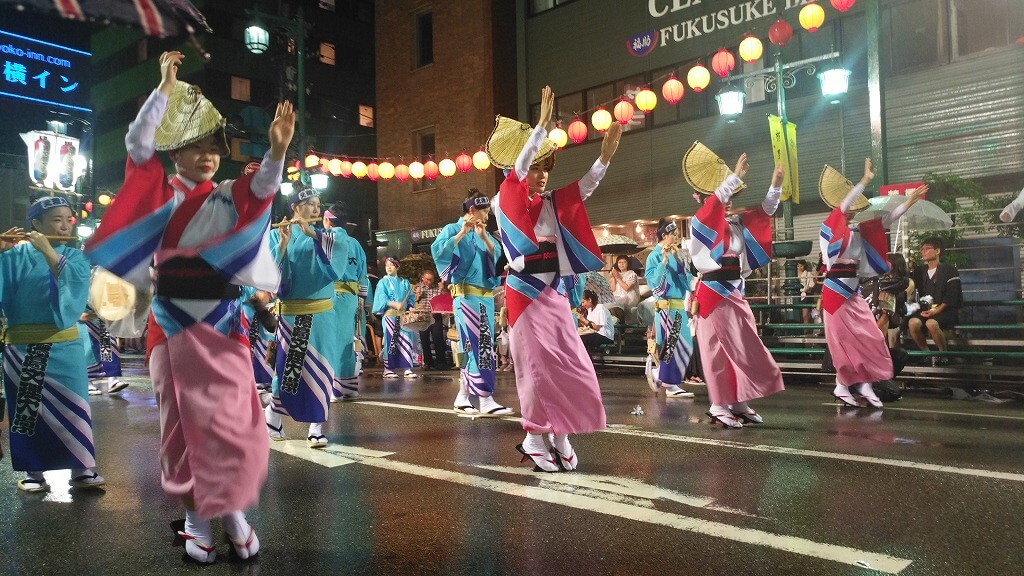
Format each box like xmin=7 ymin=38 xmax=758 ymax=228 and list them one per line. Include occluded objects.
xmin=720 ymin=47 xmax=850 ymax=322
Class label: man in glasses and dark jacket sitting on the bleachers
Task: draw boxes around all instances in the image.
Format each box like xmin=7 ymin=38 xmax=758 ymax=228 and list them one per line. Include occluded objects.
xmin=907 ymin=237 xmax=964 ymax=364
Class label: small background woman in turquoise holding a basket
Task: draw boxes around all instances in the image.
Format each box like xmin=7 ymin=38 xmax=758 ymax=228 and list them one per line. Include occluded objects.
xmin=373 ymin=256 xmax=418 ymax=379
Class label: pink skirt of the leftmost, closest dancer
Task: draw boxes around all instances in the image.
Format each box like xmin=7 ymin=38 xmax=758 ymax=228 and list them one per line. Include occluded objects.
xmin=150 ymin=323 xmax=269 ymax=519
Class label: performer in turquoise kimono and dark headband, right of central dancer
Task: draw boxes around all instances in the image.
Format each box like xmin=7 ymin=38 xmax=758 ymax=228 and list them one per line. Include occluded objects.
xmin=644 ymin=218 xmax=693 ymax=398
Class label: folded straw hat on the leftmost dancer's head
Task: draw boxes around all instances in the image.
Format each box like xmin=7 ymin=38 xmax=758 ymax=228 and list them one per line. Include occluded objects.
xmin=153 ymin=80 xmax=228 ymax=155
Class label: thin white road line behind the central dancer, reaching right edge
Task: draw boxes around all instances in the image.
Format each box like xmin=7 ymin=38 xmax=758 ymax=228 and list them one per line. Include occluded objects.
xmin=353 ymin=402 xmax=1024 ymax=482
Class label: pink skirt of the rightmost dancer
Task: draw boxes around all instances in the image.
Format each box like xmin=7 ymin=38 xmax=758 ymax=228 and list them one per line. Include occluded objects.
xmin=823 ymin=294 xmax=893 ymax=386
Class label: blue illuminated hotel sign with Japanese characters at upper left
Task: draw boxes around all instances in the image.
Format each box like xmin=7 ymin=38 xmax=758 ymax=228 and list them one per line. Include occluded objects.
xmin=0 ymin=30 xmax=92 ymax=112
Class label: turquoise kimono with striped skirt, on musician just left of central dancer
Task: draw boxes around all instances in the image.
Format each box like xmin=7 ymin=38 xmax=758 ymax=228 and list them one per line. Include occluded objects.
xmin=430 ymin=218 xmax=502 ymax=396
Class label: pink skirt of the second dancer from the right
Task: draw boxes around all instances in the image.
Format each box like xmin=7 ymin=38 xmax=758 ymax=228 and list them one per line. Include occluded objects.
xmin=697 ymin=291 xmax=785 ymax=406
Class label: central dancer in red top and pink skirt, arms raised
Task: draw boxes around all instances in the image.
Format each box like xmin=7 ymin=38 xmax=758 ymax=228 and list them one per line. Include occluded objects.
xmin=493 ymin=86 xmax=622 ymax=471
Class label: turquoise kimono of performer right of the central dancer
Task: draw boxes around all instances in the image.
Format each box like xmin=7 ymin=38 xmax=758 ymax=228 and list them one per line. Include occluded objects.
xmin=644 ymin=244 xmax=693 ymax=384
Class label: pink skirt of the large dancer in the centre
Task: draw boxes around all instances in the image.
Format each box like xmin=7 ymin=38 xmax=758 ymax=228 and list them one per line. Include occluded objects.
xmin=509 ymin=286 xmax=605 ymax=434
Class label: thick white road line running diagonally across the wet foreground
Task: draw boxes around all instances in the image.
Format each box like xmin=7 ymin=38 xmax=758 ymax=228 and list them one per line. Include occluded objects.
xmin=273 ymin=441 xmax=910 ymax=574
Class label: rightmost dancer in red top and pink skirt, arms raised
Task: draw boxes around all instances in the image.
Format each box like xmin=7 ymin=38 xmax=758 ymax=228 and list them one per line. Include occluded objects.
xmin=820 ymin=158 xmax=928 ymax=408
